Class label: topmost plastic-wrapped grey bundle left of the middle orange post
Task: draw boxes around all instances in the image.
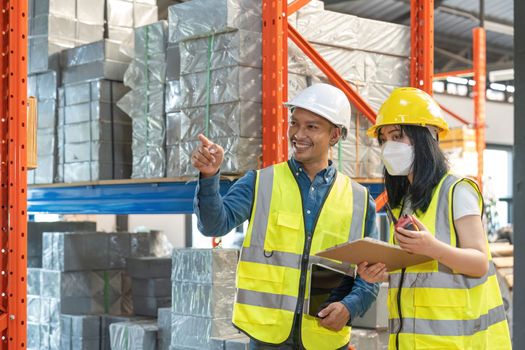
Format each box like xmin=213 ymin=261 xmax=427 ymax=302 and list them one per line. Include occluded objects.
xmin=168 ymin=0 xmax=262 ymax=43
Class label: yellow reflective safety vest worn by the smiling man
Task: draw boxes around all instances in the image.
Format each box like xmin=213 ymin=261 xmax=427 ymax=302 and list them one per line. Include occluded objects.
xmin=233 ymin=162 xmax=368 ymax=350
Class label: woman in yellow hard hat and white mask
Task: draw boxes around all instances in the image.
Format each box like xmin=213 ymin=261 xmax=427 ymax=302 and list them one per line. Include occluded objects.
xmin=358 ymin=88 xmax=511 ymax=349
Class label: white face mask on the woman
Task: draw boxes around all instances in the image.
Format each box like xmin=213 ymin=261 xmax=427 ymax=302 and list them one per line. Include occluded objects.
xmin=381 ymin=141 xmax=414 ymax=176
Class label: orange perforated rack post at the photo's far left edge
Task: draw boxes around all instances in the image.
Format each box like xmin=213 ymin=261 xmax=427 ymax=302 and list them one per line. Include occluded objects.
xmin=0 ymin=0 xmax=28 ymax=349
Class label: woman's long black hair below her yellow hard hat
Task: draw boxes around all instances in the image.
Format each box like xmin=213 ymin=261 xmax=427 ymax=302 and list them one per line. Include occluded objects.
xmin=378 ymin=125 xmax=448 ymax=212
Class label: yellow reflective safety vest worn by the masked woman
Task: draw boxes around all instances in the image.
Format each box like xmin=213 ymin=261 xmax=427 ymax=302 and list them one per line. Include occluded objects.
xmin=388 ymin=174 xmax=511 ymax=350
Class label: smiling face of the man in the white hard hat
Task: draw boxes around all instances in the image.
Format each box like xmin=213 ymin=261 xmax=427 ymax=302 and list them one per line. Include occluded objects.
xmin=288 ymin=108 xmax=340 ymax=164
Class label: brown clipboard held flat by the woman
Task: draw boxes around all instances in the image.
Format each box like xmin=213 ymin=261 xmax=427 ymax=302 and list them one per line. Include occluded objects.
xmin=316 ymin=237 xmax=433 ymax=271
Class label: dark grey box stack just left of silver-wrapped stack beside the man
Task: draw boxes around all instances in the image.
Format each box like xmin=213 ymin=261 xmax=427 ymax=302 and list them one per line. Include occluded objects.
xmin=126 ymin=257 xmax=171 ymax=317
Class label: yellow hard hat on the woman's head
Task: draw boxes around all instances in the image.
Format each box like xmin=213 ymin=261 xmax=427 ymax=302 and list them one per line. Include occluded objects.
xmin=367 ymin=87 xmax=448 ymax=137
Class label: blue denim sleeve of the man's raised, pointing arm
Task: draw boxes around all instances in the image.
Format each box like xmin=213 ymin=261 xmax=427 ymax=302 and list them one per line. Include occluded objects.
xmin=193 ymin=171 xmax=256 ymax=237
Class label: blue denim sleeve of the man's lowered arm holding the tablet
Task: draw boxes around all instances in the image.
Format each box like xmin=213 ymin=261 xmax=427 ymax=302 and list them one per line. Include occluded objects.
xmin=341 ymin=197 xmax=379 ymax=325
